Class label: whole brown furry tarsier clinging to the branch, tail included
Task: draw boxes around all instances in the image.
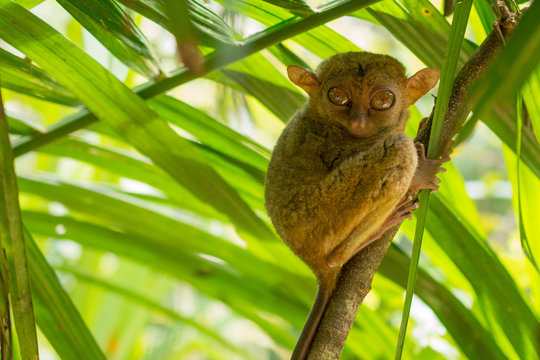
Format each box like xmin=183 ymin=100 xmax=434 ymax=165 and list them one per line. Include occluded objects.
xmin=265 ymin=52 xmax=448 ymax=360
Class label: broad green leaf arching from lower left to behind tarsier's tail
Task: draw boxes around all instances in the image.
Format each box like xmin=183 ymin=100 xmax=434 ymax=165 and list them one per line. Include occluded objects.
xmin=24 ymin=208 xmax=304 ymax=347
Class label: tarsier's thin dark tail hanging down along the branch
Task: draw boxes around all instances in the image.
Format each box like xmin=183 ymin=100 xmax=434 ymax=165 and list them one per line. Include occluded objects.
xmin=291 ymin=286 xmax=332 ymax=360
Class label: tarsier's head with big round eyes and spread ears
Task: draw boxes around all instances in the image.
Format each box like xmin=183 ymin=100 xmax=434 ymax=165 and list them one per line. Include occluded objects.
xmin=287 ymin=52 xmax=439 ymax=138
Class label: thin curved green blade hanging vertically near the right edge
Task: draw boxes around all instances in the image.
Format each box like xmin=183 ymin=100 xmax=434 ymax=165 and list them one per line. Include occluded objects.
xmin=516 ymin=91 xmax=540 ymax=273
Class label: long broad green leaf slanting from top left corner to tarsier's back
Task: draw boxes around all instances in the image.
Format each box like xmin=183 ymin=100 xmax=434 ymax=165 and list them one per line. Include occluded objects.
xmin=0 ymin=0 xmax=274 ymax=239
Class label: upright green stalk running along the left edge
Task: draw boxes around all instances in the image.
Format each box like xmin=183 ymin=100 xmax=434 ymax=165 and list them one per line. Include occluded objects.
xmin=0 ymin=84 xmax=39 ymax=360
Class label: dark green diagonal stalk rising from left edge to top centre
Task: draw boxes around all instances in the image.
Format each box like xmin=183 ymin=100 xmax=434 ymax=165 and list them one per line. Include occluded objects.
xmin=13 ymin=0 xmax=380 ymax=157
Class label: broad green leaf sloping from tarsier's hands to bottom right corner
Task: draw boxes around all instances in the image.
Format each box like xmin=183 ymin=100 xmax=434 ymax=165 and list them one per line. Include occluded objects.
xmin=426 ymin=193 xmax=540 ymax=359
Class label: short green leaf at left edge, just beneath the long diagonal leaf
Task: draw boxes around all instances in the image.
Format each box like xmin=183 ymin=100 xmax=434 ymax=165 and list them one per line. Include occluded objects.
xmin=0 ymin=49 xmax=80 ymax=106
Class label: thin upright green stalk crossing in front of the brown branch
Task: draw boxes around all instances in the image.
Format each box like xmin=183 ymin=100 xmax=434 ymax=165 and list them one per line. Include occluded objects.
xmin=395 ymin=0 xmax=473 ymax=360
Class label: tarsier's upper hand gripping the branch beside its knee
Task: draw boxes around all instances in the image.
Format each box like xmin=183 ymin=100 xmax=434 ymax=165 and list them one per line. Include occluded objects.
xmin=409 ymin=143 xmax=450 ymax=191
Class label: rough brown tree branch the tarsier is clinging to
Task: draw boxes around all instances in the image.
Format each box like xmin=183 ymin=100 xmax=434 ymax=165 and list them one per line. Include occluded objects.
xmin=307 ymin=9 xmax=520 ymax=360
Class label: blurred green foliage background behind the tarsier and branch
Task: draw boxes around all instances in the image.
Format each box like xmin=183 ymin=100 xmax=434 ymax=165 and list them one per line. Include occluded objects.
xmin=0 ymin=0 xmax=540 ymax=360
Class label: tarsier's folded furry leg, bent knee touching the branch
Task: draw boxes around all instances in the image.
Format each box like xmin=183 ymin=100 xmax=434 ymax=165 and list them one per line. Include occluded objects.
xmin=321 ymin=134 xmax=417 ymax=263
